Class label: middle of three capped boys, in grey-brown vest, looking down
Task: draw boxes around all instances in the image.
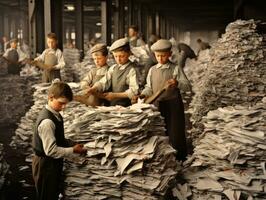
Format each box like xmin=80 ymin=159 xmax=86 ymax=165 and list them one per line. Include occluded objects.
xmin=88 ymin=38 xmax=139 ymax=106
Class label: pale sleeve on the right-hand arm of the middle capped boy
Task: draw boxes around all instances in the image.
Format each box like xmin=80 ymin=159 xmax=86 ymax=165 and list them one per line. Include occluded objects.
xmin=125 ymin=68 xmax=139 ymax=99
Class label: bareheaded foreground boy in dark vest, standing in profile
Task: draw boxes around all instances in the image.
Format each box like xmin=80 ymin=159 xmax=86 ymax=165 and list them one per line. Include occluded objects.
xmin=32 ymin=82 xmax=86 ymax=200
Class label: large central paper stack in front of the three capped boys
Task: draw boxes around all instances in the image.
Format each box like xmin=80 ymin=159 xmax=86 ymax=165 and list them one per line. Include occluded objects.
xmin=64 ymin=104 xmax=179 ymax=200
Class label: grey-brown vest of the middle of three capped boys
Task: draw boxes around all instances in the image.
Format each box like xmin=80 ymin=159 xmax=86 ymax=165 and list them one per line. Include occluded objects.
xmin=111 ymin=63 xmax=134 ymax=107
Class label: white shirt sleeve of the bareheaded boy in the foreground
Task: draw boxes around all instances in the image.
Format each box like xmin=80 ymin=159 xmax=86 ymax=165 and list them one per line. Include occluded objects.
xmin=38 ymin=119 xmax=73 ymax=159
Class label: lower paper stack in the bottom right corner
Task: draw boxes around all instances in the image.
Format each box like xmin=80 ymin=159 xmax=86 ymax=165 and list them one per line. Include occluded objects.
xmin=173 ymin=98 xmax=266 ymax=200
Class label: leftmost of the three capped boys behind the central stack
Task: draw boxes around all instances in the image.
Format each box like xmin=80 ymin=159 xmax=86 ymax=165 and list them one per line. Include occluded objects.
xmin=80 ymin=44 xmax=109 ymax=105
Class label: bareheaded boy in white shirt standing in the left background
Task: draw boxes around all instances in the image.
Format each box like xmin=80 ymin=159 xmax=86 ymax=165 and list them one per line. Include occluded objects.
xmin=32 ymin=33 xmax=65 ymax=83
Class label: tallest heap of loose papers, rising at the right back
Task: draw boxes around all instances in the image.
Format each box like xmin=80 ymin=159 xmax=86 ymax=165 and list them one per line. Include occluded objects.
xmin=188 ymin=20 xmax=266 ymax=139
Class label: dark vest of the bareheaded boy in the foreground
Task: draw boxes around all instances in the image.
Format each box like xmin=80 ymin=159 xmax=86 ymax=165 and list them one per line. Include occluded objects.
xmin=32 ymin=108 xmax=65 ymax=156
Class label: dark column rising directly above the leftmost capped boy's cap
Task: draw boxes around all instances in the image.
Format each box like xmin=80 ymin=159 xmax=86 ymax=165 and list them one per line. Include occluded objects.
xmin=101 ymin=0 xmax=112 ymax=45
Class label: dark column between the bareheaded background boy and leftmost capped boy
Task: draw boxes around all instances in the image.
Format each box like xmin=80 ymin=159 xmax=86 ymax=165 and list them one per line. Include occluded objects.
xmin=75 ymin=0 xmax=84 ymax=59
